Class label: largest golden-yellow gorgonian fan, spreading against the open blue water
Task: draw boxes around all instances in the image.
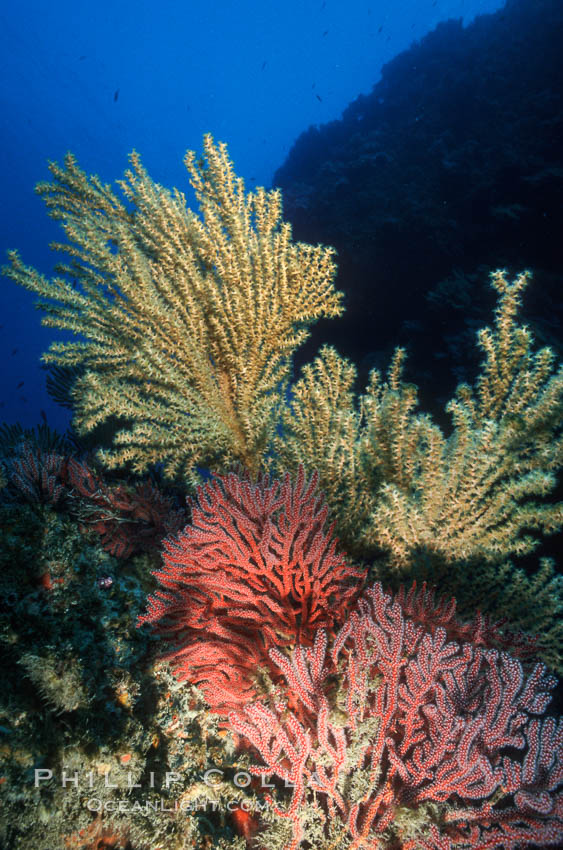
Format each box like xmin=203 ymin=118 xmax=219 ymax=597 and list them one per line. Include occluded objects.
xmin=6 ymin=135 xmax=342 ymax=480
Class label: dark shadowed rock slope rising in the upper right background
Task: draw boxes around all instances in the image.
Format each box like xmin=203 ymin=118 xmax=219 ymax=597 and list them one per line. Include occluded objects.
xmin=274 ymin=0 xmax=563 ymax=401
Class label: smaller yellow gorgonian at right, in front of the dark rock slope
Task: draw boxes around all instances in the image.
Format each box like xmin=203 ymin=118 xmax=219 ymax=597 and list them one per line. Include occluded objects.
xmin=277 ymin=271 xmax=563 ymax=568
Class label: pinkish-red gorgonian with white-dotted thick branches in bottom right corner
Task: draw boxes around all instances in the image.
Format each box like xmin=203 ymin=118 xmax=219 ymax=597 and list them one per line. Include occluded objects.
xmin=229 ymin=584 xmax=563 ymax=850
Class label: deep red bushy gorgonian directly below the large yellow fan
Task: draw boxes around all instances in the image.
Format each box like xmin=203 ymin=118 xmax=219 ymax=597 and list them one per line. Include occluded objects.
xmin=139 ymin=467 xmax=364 ymax=713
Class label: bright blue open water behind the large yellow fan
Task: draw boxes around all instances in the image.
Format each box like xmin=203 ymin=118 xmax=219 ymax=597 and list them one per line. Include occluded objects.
xmin=0 ymin=0 xmax=502 ymax=429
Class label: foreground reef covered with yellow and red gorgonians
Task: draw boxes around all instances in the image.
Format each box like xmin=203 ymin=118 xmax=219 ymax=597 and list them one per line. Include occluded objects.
xmin=0 ymin=126 xmax=563 ymax=850
